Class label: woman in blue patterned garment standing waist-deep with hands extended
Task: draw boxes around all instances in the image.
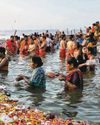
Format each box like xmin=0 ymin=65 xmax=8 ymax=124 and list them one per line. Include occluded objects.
xmin=16 ymin=55 xmax=46 ymax=89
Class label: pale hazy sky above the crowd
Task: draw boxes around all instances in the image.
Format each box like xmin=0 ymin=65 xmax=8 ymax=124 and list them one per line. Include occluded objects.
xmin=0 ymin=0 xmax=100 ymax=30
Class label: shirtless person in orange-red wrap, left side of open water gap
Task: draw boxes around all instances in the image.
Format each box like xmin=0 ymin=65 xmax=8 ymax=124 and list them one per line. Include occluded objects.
xmin=39 ymin=36 xmax=46 ymax=57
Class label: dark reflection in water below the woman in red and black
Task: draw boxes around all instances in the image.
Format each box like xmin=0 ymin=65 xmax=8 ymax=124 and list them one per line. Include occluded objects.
xmin=62 ymin=89 xmax=83 ymax=117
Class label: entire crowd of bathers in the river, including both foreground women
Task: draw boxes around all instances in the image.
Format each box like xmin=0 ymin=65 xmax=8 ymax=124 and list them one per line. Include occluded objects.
xmin=0 ymin=21 xmax=100 ymax=90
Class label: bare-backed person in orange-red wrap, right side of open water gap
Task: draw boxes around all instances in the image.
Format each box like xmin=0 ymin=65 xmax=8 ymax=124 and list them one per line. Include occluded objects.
xmin=59 ymin=35 xmax=66 ymax=59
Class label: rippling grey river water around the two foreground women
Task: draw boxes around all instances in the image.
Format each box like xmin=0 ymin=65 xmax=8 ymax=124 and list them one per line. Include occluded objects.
xmin=0 ymin=51 xmax=100 ymax=123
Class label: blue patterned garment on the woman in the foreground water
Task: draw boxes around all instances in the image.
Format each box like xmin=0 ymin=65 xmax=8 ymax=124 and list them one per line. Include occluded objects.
xmin=30 ymin=67 xmax=46 ymax=88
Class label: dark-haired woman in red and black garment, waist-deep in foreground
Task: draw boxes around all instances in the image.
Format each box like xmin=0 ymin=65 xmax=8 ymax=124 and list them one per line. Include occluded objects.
xmin=59 ymin=57 xmax=83 ymax=90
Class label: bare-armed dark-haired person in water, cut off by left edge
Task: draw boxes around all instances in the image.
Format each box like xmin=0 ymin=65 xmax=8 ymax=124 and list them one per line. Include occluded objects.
xmin=0 ymin=47 xmax=9 ymax=72
